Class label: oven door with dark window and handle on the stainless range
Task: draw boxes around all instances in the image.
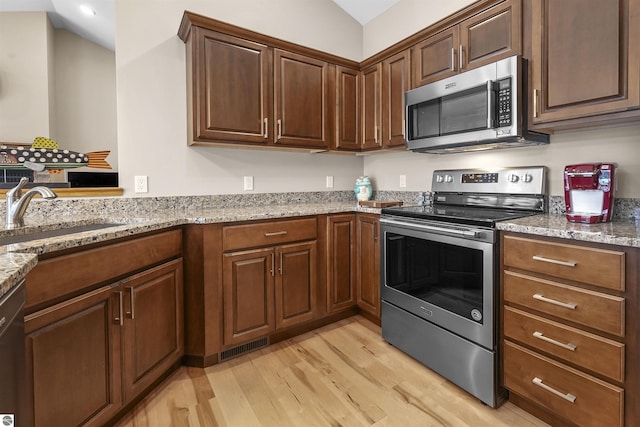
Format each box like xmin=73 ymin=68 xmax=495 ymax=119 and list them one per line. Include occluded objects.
xmin=380 ymin=216 xmax=496 ymax=350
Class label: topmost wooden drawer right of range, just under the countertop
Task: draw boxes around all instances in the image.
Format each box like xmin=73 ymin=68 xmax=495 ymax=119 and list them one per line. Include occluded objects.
xmin=504 ymin=236 xmax=625 ymax=291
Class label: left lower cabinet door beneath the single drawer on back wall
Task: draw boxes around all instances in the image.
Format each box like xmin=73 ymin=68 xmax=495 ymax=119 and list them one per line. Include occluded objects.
xmin=222 ymin=248 xmax=276 ymax=346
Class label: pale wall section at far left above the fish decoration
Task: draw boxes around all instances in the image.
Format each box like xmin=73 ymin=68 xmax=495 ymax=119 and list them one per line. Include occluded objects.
xmin=0 ymin=12 xmax=53 ymax=144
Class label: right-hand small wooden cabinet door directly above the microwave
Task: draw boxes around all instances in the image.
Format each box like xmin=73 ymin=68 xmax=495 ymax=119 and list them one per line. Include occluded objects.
xmin=458 ymin=0 xmax=522 ymax=71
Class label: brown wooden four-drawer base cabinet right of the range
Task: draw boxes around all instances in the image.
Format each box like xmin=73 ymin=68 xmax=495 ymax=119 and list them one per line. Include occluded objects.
xmin=501 ymin=233 xmax=638 ymax=426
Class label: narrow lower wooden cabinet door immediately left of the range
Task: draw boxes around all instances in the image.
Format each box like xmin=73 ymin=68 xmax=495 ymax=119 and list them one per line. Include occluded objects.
xmin=357 ymin=214 xmax=380 ymax=318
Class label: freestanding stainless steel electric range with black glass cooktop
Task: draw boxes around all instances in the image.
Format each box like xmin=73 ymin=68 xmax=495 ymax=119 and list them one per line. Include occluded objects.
xmin=380 ymin=166 xmax=547 ymax=407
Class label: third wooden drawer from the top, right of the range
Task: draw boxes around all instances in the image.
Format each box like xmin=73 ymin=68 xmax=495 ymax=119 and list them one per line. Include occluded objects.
xmin=504 ymin=307 xmax=624 ymax=382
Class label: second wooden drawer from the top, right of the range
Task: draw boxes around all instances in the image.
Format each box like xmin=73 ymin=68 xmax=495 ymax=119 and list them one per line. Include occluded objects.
xmin=504 ymin=271 xmax=624 ymax=337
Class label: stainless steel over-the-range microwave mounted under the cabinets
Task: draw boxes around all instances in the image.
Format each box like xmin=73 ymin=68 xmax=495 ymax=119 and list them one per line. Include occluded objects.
xmin=405 ymin=56 xmax=549 ymax=154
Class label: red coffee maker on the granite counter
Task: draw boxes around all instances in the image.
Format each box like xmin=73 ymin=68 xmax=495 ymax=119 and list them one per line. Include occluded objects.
xmin=564 ymin=163 xmax=616 ymax=224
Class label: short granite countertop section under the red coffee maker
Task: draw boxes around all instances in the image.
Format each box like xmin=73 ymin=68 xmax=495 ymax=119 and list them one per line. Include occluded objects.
xmin=497 ymin=214 xmax=640 ymax=248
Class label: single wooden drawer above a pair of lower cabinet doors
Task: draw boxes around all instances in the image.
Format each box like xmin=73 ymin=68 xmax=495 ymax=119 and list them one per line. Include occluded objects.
xmin=222 ymin=218 xmax=317 ymax=251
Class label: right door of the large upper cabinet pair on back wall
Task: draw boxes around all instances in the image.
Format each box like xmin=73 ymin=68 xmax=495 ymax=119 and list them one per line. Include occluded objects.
xmin=274 ymin=49 xmax=330 ymax=148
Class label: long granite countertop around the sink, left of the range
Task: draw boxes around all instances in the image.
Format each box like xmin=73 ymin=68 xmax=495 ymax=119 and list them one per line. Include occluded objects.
xmin=0 ymin=202 xmax=380 ymax=298
